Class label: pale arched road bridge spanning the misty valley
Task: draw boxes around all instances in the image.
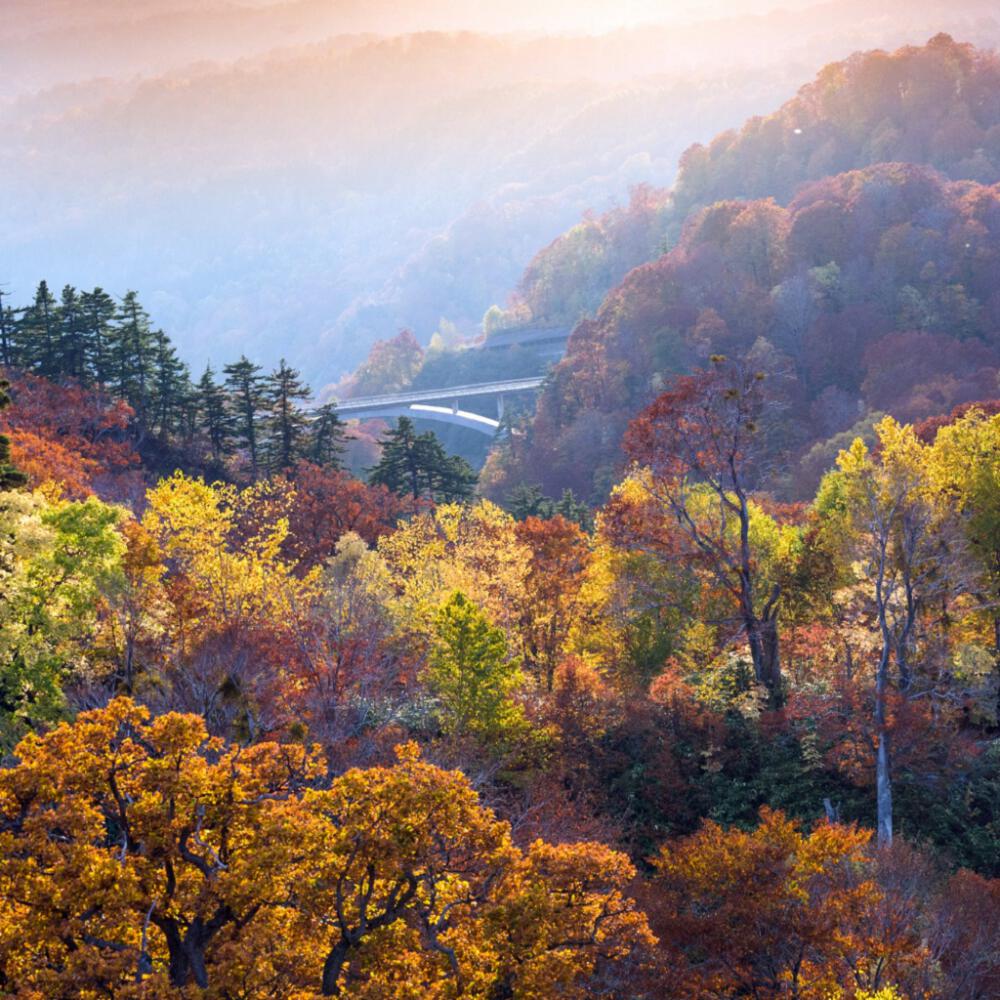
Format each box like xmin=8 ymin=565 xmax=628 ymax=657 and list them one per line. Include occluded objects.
xmin=337 ymin=375 xmax=545 ymax=437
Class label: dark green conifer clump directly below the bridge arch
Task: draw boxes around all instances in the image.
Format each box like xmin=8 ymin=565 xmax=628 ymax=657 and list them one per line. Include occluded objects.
xmin=368 ymin=417 xmax=476 ymax=503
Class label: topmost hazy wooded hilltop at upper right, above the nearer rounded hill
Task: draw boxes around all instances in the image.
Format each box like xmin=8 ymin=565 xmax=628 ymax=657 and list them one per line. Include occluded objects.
xmin=674 ymin=34 xmax=1000 ymax=209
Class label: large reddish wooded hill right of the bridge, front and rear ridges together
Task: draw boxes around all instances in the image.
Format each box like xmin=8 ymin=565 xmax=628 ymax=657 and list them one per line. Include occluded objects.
xmin=487 ymin=35 xmax=1000 ymax=504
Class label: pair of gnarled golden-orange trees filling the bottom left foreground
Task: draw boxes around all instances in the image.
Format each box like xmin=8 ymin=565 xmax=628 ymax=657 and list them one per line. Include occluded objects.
xmin=0 ymin=698 xmax=654 ymax=1000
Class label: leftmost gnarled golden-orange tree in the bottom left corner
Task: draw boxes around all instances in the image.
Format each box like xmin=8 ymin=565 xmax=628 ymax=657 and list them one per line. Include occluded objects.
xmin=0 ymin=699 xmax=317 ymax=997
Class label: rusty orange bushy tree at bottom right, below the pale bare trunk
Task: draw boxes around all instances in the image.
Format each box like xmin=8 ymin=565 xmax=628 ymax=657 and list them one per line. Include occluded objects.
xmin=654 ymin=808 xmax=926 ymax=1000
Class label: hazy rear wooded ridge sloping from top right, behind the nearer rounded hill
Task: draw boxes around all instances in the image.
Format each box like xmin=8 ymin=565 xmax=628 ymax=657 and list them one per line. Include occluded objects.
xmin=504 ymin=35 xmax=1000 ymax=334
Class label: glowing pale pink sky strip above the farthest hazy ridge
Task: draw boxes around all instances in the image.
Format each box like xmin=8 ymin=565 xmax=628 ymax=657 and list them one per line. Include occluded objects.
xmin=0 ymin=0 xmax=810 ymax=94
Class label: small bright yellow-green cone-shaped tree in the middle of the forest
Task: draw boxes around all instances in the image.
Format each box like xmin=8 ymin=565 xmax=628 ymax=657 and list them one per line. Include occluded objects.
xmin=424 ymin=591 xmax=525 ymax=743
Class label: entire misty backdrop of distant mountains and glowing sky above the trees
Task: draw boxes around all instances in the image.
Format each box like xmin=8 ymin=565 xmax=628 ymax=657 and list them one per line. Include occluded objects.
xmin=0 ymin=0 xmax=1000 ymax=384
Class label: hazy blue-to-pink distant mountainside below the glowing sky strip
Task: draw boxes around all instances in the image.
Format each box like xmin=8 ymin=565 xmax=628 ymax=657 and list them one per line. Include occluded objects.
xmin=0 ymin=34 xmax=791 ymax=382
